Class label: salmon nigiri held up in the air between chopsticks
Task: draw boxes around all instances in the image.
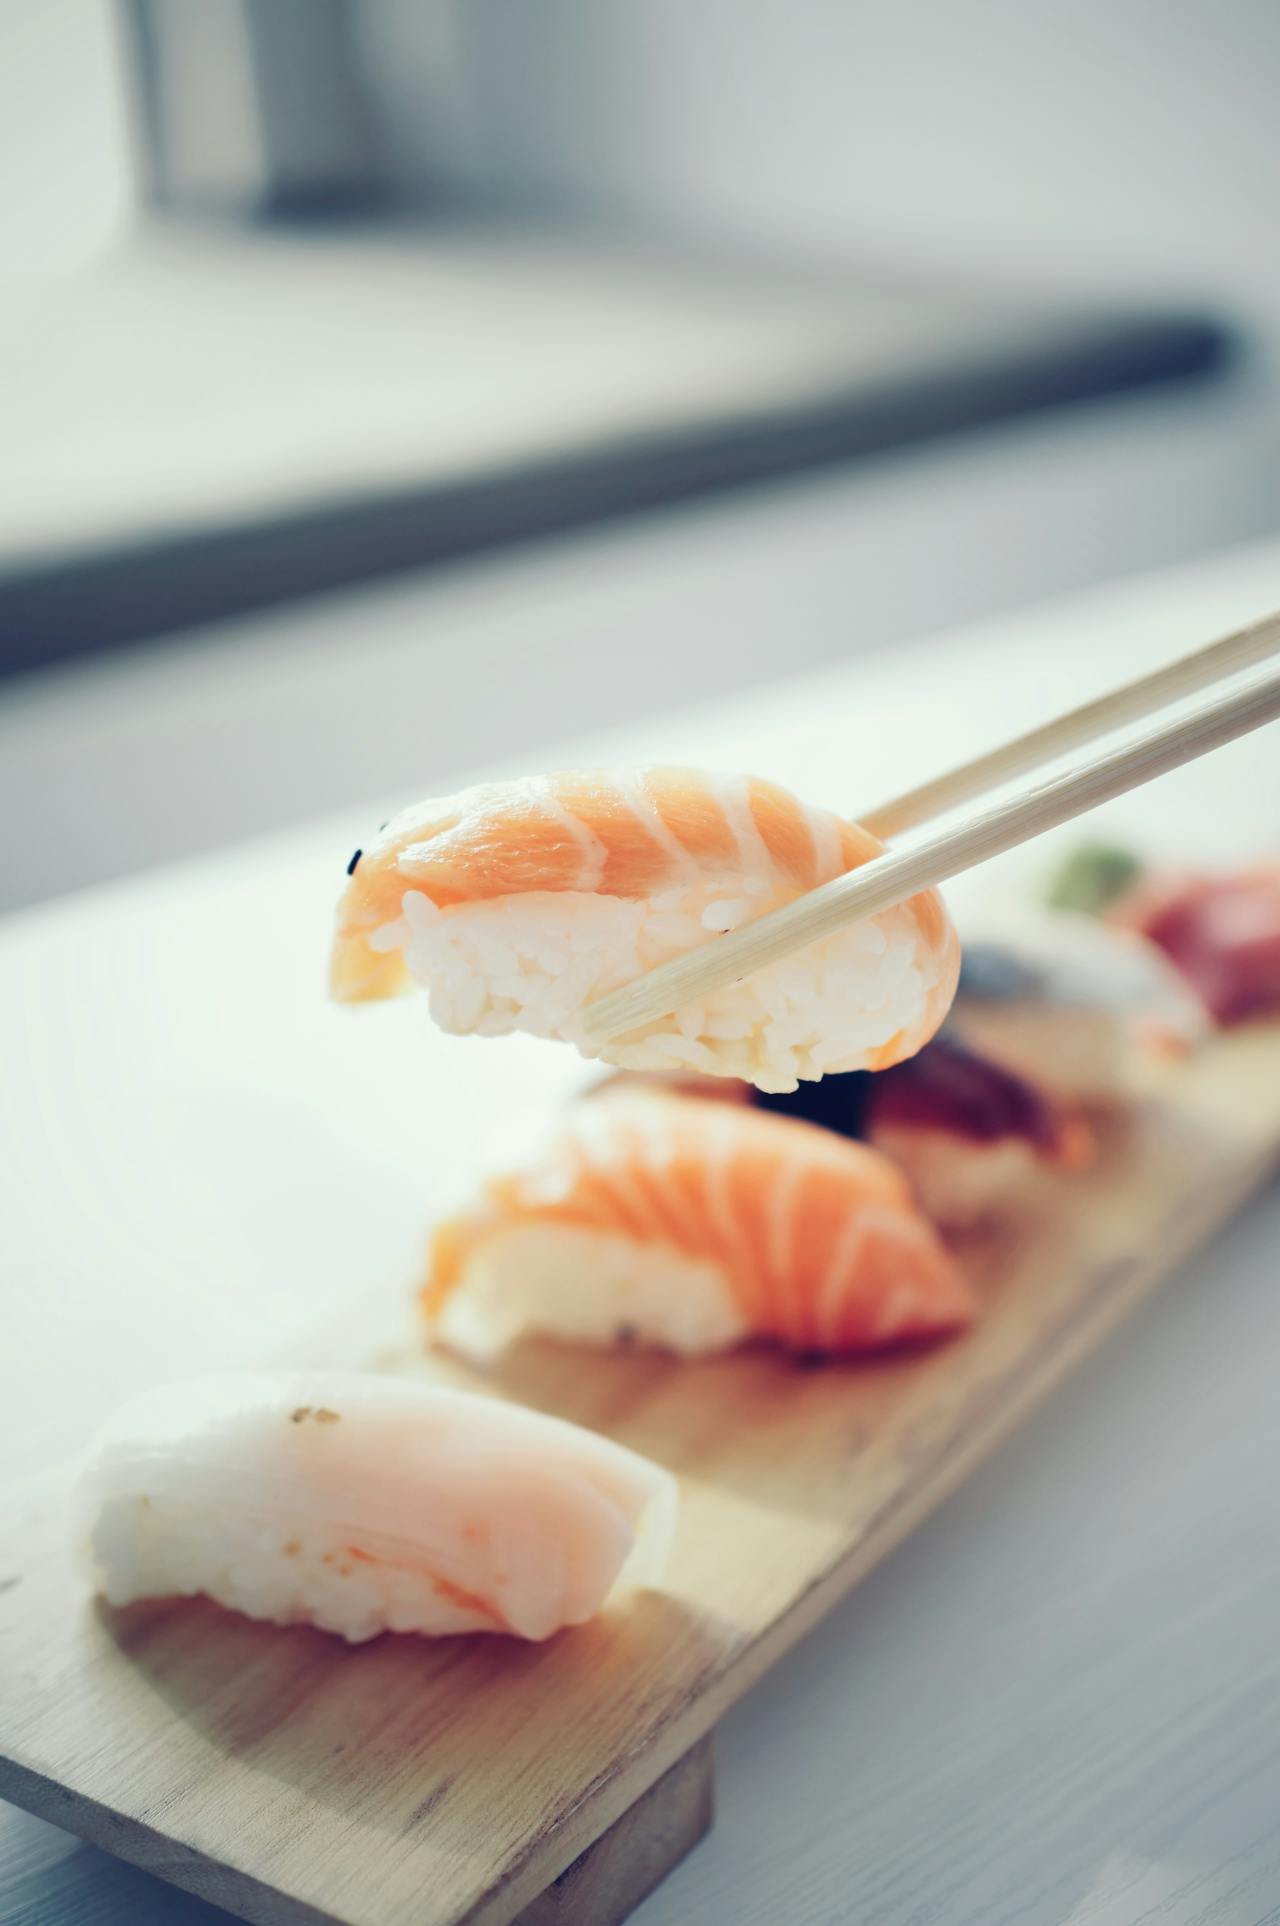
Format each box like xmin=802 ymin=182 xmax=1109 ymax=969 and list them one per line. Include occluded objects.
xmin=331 ymin=768 xmax=960 ymax=1090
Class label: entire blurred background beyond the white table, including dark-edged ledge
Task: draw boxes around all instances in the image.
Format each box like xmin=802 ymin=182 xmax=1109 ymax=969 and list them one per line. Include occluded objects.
xmin=0 ymin=0 xmax=1280 ymax=909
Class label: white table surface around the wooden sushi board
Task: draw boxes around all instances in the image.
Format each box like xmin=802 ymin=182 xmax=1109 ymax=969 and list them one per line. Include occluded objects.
xmin=0 ymin=547 xmax=1280 ymax=1926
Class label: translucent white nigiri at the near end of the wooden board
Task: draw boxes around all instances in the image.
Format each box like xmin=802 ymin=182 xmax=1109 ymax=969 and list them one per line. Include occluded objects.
xmin=75 ymin=1371 xmax=676 ymax=1643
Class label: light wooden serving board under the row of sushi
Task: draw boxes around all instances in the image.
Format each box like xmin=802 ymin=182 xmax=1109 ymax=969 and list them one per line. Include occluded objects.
xmin=0 ymin=1027 xmax=1280 ymax=1926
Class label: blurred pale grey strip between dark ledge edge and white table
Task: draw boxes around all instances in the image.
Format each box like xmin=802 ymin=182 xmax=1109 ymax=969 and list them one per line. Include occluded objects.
xmin=0 ymin=369 xmax=1278 ymax=913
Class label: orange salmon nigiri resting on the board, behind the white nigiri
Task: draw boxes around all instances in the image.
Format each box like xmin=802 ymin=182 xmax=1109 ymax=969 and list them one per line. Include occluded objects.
xmin=422 ymin=1088 xmax=974 ymax=1358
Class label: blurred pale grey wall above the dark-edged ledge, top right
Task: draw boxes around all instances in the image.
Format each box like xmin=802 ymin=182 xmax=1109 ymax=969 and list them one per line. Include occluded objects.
xmin=362 ymin=0 xmax=1280 ymax=314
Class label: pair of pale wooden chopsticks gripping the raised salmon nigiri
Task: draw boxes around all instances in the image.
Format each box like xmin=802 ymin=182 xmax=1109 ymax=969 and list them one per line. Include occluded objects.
xmin=581 ymin=611 xmax=1280 ymax=1050
